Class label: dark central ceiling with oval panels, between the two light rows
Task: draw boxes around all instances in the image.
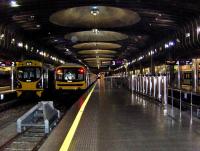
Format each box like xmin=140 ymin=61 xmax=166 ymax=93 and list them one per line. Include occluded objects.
xmin=0 ymin=0 xmax=200 ymax=69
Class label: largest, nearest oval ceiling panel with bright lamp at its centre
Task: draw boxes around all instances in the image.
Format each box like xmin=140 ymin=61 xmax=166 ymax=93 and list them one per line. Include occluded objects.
xmin=49 ymin=6 xmax=141 ymax=28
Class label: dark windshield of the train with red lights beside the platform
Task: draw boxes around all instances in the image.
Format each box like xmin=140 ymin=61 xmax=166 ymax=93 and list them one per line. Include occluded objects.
xmin=56 ymin=68 xmax=84 ymax=82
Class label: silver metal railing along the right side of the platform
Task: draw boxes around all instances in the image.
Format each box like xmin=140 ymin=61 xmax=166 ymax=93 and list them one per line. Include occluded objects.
xmin=111 ymin=75 xmax=200 ymax=119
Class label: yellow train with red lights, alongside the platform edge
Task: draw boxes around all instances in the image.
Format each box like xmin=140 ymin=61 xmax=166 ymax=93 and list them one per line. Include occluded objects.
xmin=55 ymin=63 xmax=97 ymax=91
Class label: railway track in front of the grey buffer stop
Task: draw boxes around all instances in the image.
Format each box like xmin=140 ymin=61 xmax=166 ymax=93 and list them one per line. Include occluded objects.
xmin=0 ymin=127 xmax=47 ymax=151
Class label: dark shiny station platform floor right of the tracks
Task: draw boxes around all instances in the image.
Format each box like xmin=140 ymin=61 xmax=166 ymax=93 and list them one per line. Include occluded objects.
xmin=42 ymin=79 xmax=200 ymax=151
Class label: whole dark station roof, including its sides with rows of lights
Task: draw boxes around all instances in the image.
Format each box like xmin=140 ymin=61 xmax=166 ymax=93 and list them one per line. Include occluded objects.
xmin=0 ymin=0 xmax=200 ymax=69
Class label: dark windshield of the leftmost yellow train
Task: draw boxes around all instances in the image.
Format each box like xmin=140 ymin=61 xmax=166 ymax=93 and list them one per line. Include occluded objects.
xmin=17 ymin=67 xmax=42 ymax=82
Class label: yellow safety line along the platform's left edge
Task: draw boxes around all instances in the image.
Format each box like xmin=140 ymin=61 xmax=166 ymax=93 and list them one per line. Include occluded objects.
xmin=59 ymin=84 xmax=96 ymax=151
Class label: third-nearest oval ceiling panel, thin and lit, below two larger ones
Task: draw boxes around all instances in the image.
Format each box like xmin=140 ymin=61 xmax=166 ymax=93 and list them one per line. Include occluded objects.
xmin=73 ymin=42 xmax=121 ymax=50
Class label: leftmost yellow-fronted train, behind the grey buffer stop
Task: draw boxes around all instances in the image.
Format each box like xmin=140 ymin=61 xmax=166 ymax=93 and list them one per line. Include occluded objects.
xmin=15 ymin=60 xmax=48 ymax=97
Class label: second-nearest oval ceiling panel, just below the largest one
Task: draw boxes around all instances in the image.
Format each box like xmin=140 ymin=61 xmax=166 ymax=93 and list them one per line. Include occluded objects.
xmin=65 ymin=29 xmax=128 ymax=42
